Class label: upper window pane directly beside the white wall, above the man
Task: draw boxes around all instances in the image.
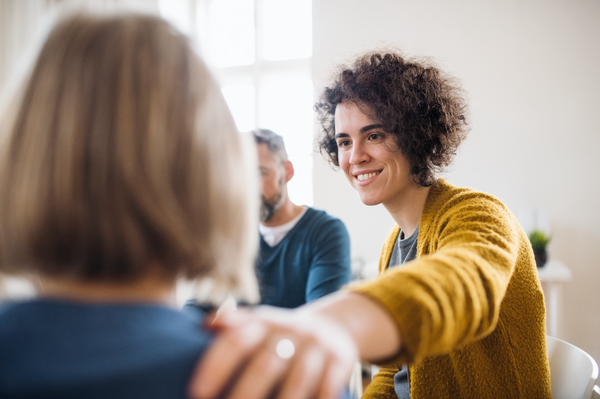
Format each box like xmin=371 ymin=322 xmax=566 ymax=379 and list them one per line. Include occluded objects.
xmin=260 ymin=0 xmax=312 ymax=60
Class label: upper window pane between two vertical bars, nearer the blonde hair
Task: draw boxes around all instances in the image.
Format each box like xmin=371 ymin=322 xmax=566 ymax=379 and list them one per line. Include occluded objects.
xmin=209 ymin=0 xmax=254 ymax=67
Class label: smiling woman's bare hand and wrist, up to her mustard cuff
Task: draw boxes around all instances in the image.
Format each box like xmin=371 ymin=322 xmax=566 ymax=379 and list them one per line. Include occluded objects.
xmin=190 ymin=292 xmax=401 ymax=399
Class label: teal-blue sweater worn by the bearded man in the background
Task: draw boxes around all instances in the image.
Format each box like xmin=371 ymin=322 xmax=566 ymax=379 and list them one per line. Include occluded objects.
xmin=256 ymin=208 xmax=351 ymax=308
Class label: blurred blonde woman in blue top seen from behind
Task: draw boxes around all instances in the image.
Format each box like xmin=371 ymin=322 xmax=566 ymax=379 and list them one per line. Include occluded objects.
xmin=0 ymin=10 xmax=258 ymax=399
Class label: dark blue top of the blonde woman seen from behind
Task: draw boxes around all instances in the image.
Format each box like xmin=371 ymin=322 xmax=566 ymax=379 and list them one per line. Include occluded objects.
xmin=0 ymin=300 xmax=211 ymax=399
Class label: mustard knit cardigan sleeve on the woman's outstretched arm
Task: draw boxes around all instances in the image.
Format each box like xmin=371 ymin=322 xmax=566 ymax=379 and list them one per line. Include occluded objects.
xmin=351 ymin=179 xmax=520 ymax=364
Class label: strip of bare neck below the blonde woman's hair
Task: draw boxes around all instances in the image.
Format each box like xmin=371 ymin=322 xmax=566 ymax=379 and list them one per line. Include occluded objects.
xmin=40 ymin=271 xmax=176 ymax=307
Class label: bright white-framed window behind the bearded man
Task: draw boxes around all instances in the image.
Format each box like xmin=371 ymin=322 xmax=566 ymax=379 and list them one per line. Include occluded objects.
xmin=159 ymin=0 xmax=313 ymax=205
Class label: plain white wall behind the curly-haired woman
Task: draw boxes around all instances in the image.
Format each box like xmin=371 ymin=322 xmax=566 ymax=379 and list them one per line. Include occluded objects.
xmin=313 ymin=0 xmax=600 ymax=361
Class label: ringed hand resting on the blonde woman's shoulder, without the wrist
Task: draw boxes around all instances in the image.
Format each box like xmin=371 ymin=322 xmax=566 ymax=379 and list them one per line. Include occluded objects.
xmin=190 ymin=306 xmax=358 ymax=399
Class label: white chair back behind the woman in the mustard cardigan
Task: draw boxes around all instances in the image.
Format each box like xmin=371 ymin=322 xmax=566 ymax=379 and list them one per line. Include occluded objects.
xmin=546 ymin=336 xmax=598 ymax=399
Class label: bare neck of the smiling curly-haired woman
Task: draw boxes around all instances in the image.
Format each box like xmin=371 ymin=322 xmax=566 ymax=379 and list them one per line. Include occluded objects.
xmin=383 ymin=184 xmax=431 ymax=237
